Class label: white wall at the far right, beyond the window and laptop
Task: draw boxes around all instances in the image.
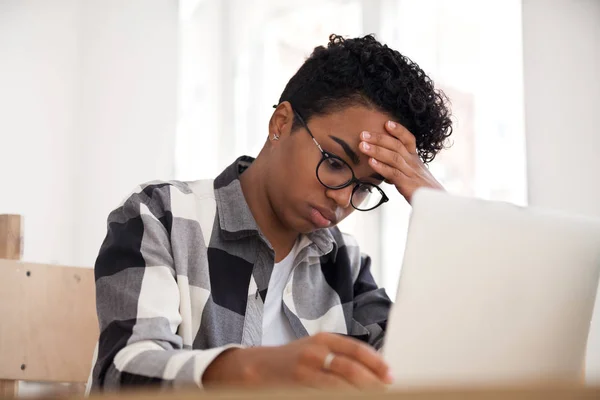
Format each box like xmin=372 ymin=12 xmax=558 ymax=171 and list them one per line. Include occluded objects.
xmin=523 ymin=0 xmax=600 ymax=383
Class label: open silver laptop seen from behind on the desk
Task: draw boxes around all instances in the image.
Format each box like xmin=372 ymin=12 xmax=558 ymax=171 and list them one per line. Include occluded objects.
xmin=383 ymin=189 xmax=600 ymax=388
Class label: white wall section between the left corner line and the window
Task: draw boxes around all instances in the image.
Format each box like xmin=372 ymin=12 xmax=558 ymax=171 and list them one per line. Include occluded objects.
xmin=74 ymin=0 xmax=178 ymax=265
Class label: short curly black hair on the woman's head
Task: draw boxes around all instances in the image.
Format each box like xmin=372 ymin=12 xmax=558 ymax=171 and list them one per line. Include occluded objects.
xmin=279 ymin=35 xmax=452 ymax=163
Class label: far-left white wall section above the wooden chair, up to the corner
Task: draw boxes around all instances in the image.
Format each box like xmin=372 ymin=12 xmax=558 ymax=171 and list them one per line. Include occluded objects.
xmin=0 ymin=0 xmax=78 ymax=263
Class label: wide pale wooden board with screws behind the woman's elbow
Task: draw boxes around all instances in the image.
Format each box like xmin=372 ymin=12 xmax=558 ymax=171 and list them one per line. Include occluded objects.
xmin=0 ymin=260 xmax=98 ymax=382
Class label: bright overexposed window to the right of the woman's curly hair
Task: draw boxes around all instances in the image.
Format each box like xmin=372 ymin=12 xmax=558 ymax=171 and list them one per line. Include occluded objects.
xmin=380 ymin=0 xmax=527 ymax=296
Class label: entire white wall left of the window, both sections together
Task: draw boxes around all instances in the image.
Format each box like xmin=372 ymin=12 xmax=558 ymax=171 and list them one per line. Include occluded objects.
xmin=0 ymin=0 xmax=178 ymax=266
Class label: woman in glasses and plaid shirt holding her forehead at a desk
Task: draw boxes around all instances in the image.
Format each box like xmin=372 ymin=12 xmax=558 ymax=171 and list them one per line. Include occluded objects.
xmin=93 ymin=35 xmax=452 ymax=389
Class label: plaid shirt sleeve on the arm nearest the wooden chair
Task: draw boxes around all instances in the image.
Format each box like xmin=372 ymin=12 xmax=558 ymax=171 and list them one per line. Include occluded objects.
xmin=93 ymin=184 xmax=239 ymax=390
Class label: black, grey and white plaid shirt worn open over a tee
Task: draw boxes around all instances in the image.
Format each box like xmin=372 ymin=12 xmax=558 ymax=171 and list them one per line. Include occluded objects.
xmin=93 ymin=157 xmax=391 ymax=389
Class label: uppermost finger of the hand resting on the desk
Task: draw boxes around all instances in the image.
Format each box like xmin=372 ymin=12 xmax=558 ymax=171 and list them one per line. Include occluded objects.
xmin=315 ymin=334 xmax=390 ymax=383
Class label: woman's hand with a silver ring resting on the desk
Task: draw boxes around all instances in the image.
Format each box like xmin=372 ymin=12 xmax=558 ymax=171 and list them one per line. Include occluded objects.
xmin=202 ymin=333 xmax=392 ymax=389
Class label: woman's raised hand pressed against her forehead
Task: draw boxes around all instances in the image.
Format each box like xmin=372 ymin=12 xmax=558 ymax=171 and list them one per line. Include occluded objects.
xmin=359 ymin=121 xmax=444 ymax=203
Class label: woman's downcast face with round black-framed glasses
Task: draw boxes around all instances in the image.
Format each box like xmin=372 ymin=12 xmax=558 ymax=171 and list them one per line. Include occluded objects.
xmin=267 ymin=102 xmax=390 ymax=233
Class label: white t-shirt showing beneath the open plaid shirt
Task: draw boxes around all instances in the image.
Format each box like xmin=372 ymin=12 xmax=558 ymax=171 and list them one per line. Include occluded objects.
xmin=262 ymin=240 xmax=302 ymax=346
